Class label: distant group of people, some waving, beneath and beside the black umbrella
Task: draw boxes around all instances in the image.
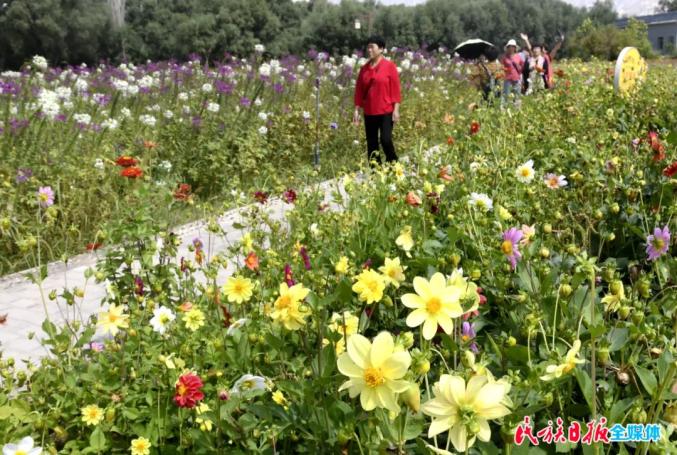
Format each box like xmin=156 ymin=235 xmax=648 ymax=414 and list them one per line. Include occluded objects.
xmin=471 ymin=33 xmax=564 ymax=105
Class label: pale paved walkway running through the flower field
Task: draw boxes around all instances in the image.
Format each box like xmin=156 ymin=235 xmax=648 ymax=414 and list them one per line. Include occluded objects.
xmin=0 ymin=175 xmax=347 ymax=367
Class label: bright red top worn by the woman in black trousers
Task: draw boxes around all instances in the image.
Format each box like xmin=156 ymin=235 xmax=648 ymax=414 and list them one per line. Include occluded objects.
xmin=355 ymin=58 xmax=402 ymax=115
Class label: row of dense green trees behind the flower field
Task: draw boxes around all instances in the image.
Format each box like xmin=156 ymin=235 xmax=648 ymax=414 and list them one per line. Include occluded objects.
xmin=0 ymin=0 xmax=632 ymax=68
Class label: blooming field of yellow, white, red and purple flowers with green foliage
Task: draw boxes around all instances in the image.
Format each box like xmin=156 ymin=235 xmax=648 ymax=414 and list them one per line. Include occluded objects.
xmin=0 ymin=50 xmax=677 ymax=455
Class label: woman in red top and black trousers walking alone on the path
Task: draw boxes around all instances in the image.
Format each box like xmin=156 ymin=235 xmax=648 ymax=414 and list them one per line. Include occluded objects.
xmin=353 ymin=36 xmax=402 ymax=164
